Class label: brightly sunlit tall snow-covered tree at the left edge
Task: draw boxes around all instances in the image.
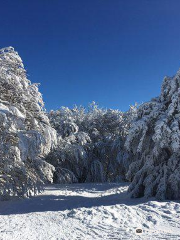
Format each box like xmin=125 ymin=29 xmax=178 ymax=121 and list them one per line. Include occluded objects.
xmin=0 ymin=47 xmax=56 ymax=199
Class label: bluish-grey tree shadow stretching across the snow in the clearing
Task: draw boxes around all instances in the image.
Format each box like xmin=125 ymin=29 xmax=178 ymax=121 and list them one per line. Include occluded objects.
xmin=0 ymin=183 xmax=155 ymax=215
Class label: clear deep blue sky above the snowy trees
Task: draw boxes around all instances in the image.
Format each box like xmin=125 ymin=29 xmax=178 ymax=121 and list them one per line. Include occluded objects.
xmin=0 ymin=0 xmax=180 ymax=111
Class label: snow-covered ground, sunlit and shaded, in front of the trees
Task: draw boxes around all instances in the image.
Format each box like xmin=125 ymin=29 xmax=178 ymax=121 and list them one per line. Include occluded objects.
xmin=0 ymin=183 xmax=180 ymax=240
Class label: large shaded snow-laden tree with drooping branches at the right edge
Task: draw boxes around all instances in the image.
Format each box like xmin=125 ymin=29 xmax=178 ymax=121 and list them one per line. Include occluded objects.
xmin=126 ymin=71 xmax=180 ymax=199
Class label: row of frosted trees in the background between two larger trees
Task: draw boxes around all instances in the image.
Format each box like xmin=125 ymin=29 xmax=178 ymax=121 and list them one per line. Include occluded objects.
xmin=47 ymin=102 xmax=136 ymax=183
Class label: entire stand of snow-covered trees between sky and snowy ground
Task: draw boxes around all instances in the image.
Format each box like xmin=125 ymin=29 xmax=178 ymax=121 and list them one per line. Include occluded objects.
xmin=0 ymin=47 xmax=180 ymax=200
